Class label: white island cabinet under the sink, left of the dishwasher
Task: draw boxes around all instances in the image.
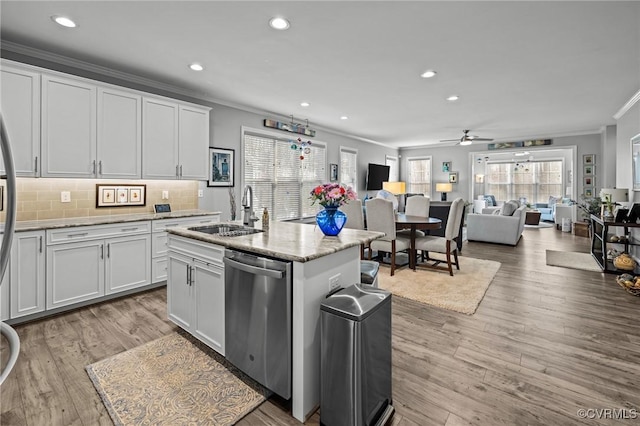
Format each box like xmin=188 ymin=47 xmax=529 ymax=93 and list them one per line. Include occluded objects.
xmin=167 ymin=235 xmax=225 ymax=355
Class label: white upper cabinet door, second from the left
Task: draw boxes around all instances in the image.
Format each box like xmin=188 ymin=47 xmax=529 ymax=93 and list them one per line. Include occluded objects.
xmin=42 ymin=75 xmax=96 ymax=178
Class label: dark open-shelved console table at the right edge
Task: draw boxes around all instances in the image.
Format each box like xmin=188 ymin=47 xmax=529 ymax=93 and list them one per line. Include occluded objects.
xmin=591 ymin=215 xmax=640 ymax=274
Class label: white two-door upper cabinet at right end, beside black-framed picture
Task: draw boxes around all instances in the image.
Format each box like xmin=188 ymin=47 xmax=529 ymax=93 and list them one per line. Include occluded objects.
xmin=142 ymin=98 xmax=209 ymax=180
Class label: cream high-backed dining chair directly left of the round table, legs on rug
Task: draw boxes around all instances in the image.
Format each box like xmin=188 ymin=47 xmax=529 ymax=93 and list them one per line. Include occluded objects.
xmin=365 ymin=198 xmax=411 ymax=276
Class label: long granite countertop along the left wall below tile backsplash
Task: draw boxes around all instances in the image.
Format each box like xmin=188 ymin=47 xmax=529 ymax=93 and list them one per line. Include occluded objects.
xmin=0 ymin=210 xmax=220 ymax=232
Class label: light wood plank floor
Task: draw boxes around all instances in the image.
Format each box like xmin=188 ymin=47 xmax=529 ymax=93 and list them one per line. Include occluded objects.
xmin=0 ymin=228 xmax=640 ymax=426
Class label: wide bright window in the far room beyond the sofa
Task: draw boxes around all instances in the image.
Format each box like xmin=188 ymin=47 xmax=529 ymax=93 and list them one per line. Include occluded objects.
xmin=485 ymin=160 xmax=564 ymax=204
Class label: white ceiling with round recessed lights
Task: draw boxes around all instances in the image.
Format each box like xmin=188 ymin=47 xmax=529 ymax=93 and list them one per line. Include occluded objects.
xmin=0 ymin=0 xmax=640 ymax=147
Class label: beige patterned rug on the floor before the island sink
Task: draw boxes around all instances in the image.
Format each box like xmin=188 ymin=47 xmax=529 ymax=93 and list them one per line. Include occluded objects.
xmin=86 ymin=333 xmax=268 ymax=425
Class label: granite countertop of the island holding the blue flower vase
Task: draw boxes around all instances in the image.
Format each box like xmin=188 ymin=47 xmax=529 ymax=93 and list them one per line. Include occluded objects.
xmin=168 ymin=221 xmax=384 ymax=262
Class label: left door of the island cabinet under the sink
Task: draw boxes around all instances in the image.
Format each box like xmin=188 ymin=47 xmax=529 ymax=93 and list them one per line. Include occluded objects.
xmin=167 ymin=251 xmax=193 ymax=331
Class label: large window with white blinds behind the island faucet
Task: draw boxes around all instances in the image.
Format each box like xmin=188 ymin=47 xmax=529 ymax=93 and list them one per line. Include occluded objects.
xmin=243 ymin=133 xmax=327 ymax=220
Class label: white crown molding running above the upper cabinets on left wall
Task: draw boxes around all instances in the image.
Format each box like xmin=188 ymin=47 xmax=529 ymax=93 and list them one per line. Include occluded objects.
xmin=2 ymin=41 xmax=398 ymax=149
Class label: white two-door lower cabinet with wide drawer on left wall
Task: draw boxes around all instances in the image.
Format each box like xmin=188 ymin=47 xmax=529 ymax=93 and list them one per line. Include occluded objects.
xmin=46 ymin=222 xmax=151 ymax=309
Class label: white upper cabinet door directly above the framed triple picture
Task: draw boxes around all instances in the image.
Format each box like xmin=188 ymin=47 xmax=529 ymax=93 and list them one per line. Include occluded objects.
xmin=97 ymin=88 xmax=142 ymax=179
